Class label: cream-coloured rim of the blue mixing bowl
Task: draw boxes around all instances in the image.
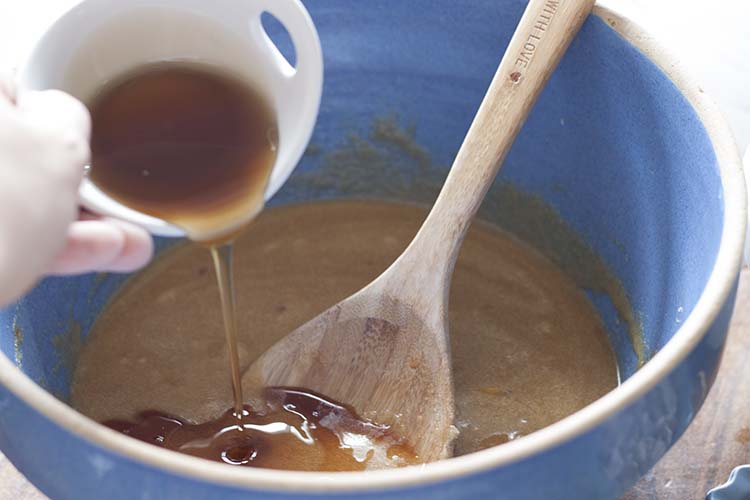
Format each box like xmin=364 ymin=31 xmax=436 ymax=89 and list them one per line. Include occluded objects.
xmin=0 ymin=1 xmax=747 ymax=493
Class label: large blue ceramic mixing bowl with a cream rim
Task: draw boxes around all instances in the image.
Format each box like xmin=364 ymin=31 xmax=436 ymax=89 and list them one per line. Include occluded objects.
xmin=0 ymin=0 xmax=746 ymax=500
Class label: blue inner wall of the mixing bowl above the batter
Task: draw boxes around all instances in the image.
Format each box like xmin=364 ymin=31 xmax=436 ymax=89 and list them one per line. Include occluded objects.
xmin=0 ymin=0 xmax=723 ymax=440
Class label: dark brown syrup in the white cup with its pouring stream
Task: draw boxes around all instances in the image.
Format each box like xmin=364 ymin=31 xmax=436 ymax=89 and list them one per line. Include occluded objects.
xmin=89 ymin=63 xmax=277 ymax=415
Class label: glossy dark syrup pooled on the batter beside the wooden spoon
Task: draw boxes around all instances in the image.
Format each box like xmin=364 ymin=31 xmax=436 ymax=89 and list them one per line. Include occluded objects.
xmin=105 ymin=387 xmax=419 ymax=471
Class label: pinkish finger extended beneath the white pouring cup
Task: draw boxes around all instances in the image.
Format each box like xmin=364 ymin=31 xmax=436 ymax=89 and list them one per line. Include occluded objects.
xmin=50 ymin=219 xmax=153 ymax=275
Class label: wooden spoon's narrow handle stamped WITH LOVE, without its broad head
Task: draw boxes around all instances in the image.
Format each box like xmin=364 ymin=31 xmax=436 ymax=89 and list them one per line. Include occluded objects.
xmin=394 ymin=0 xmax=594 ymax=291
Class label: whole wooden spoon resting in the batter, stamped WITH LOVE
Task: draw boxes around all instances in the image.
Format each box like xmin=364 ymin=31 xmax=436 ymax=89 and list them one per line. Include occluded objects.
xmin=244 ymin=0 xmax=594 ymax=462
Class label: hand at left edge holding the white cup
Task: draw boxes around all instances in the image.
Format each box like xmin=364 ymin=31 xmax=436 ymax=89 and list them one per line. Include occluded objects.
xmin=0 ymin=76 xmax=153 ymax=305
